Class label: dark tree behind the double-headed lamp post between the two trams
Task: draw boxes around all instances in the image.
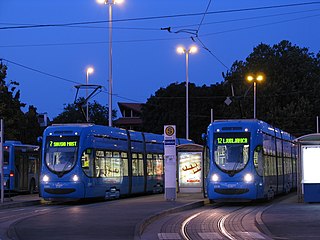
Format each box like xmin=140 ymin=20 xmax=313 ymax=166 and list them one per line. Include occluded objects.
xmin=142 ymin=83 xmax=226 ymax=143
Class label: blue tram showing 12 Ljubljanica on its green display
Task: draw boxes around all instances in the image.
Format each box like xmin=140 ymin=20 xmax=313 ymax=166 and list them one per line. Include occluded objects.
xmin=204 ymin=119 xmax=297 ymax=201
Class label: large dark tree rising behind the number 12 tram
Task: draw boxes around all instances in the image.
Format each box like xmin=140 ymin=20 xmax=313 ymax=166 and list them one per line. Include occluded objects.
xmin=222 ymin=41 xmax=320 ymax=136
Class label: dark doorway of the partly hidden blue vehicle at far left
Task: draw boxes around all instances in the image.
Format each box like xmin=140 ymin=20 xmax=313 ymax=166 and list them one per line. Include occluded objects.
xmin=14 ymin=147 xmax=28 ymax=191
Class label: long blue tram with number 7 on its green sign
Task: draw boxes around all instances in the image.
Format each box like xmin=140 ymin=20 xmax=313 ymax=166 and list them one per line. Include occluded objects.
xmin=40 ymin=124 xmax=190 ymax=200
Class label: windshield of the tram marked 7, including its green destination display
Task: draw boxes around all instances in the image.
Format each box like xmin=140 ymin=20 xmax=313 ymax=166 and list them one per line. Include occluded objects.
xmin=45 ymin=137 xmax=79 ymax=174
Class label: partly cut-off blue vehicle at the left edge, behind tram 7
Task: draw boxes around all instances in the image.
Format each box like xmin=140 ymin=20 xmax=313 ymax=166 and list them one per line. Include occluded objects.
xmin=3 ymin=141 xmax=40 ymax=193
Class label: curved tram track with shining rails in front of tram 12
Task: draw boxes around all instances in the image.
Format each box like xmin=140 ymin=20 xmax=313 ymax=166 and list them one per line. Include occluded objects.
xmin=150 ymin=204 xmax=271 ymax=240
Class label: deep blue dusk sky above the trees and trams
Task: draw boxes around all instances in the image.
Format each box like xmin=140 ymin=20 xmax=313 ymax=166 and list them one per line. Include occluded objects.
xmin=0 ymin=0 xmax=320 ymax=119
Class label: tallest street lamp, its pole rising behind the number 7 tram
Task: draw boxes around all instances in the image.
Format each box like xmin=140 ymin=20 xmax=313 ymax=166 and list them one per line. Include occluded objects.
xmin=96 ymin=0 xmax=123 ymax=127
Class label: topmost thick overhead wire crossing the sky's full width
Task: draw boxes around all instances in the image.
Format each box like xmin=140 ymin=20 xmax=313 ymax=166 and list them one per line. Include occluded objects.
xmin=0 ymin=1 xmax=320 ymax=30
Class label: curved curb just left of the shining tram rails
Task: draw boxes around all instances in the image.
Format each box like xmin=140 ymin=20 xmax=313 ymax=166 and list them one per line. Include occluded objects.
xmin=134 ymin=200 xmax=207 ymax=240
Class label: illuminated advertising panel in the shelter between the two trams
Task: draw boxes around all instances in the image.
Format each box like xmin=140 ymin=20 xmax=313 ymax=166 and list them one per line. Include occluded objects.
xmin=178 ymin=152 xmax=202 ymax=188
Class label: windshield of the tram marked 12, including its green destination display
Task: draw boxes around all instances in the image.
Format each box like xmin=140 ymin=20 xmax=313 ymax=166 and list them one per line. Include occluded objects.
xmin=214 ymin=133 xmax=250 ymax=173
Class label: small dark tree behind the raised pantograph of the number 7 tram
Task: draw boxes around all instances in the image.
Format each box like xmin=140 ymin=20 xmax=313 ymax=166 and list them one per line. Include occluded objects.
xmin=53 ymin=98 xmax=117 ymax=125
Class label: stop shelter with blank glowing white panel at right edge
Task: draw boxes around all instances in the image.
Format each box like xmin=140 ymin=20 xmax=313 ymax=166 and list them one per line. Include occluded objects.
xmin=295 ymin=133 xmax=320 ymax=202
